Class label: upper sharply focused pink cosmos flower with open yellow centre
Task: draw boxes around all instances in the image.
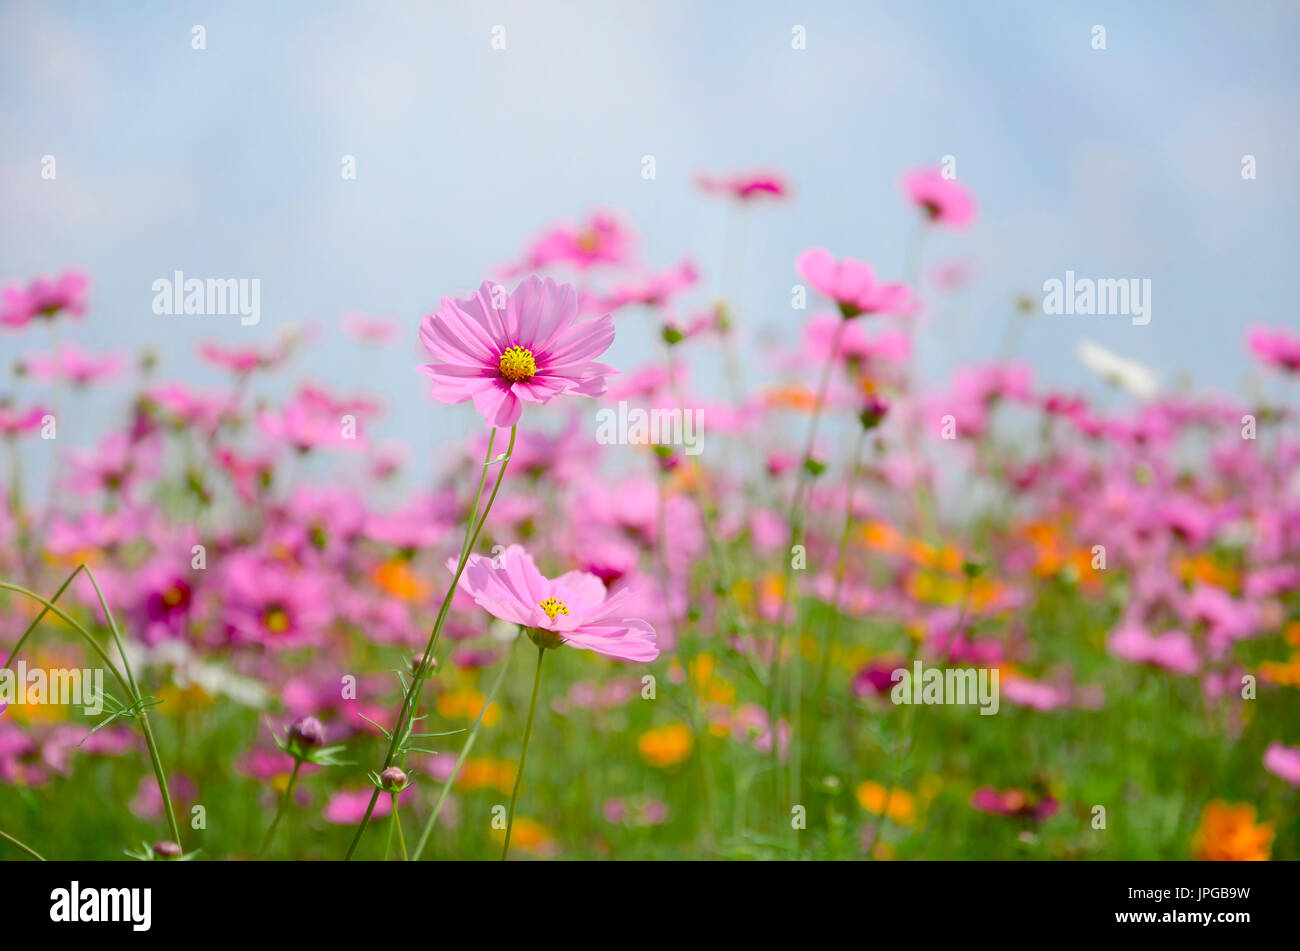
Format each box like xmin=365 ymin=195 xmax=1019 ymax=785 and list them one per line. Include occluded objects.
xmin=420 ymin=277 xmax=616 ymax=429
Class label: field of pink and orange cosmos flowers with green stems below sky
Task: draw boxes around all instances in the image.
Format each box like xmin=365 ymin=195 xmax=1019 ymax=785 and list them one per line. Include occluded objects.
xmin=0 ymin=169 xmax=1300 ymax=860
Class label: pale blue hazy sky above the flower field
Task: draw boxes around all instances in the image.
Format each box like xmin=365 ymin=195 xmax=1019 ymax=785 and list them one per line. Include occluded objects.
xmin=0 ymin=0 xmax=1300 ymax=475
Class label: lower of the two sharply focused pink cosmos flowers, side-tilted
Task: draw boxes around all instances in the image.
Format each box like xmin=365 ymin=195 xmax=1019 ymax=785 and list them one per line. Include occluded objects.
xmin=451 ymin=544 xmax=659 ymax=661
